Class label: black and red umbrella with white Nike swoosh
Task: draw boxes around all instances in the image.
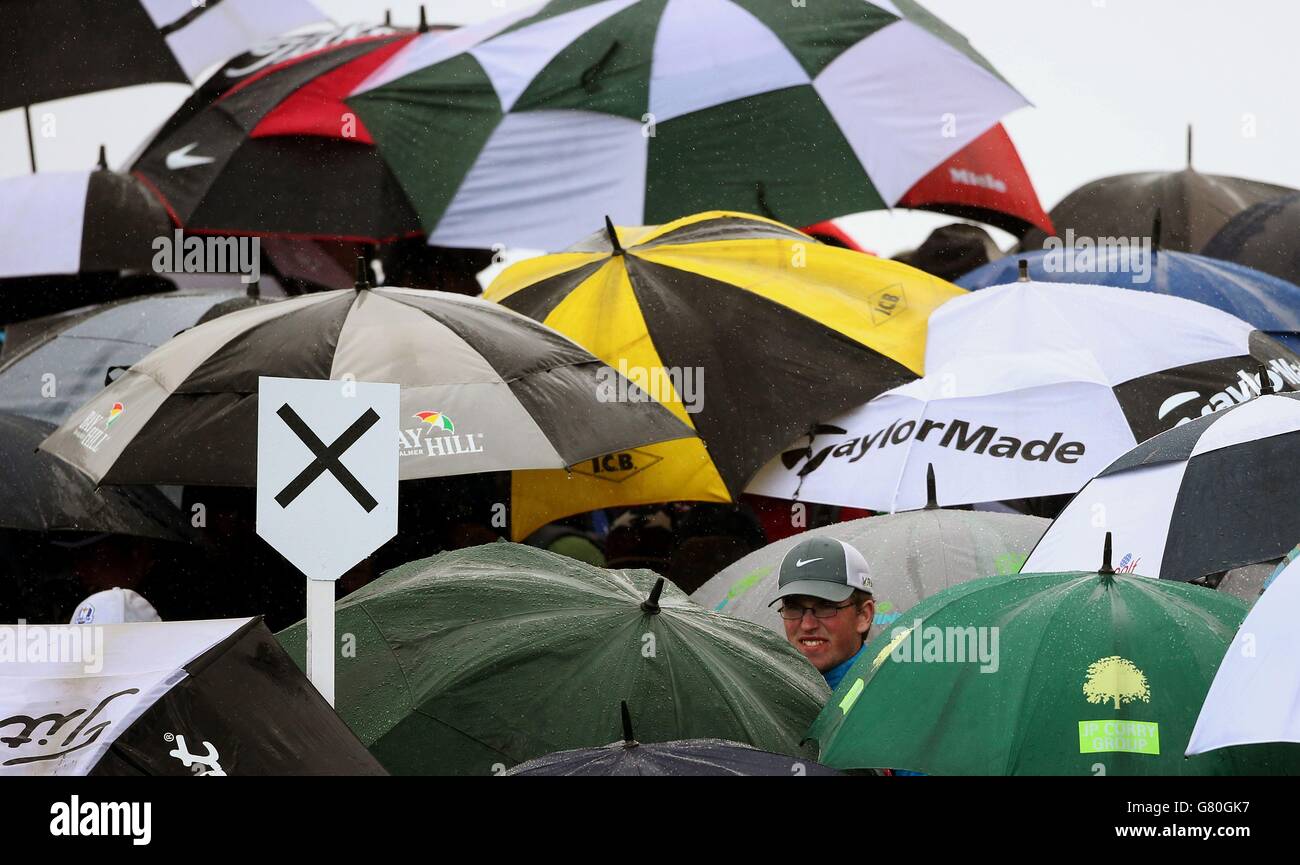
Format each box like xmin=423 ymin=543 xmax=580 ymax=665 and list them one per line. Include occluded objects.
xmin=131 ymin=26 xmax=436 ymax=242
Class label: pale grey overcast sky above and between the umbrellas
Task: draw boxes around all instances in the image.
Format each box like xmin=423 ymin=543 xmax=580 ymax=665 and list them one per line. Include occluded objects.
xmin=0 ymin=0 xmax=1300 ymax=254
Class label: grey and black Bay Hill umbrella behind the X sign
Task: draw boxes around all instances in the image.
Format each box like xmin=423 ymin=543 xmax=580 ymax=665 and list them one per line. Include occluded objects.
xmin=42 ymin=282 xmax=692 ymax=486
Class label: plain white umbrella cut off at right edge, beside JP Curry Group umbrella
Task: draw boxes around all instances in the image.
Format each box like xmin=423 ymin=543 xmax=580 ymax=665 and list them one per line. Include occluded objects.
xmin=1187 ymin=548 xmax=1300 ymax=756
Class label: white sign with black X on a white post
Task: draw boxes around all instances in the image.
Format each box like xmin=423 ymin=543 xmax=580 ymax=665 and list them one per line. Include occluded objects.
xmin=257 ymin=376 xmax=399 ymax=705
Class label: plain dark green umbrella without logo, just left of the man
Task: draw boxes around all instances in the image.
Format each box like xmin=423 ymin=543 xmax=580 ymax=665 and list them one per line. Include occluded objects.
xmin=280 ymin=541 xmax=828 ymax=775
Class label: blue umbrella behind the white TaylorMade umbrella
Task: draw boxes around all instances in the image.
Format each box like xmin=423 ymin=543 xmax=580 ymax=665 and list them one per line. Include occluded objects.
xmin=957 ymin=245 xmax=1300 ymax=351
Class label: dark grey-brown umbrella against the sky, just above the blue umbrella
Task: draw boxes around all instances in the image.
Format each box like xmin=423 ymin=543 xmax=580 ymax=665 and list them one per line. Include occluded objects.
xmin=1021 ymin=160 xmax=1295 ymax=252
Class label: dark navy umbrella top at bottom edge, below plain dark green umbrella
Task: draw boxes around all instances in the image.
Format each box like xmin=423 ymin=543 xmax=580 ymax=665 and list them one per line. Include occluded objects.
xmin=504 ymin=702 xmax=841 ymax=778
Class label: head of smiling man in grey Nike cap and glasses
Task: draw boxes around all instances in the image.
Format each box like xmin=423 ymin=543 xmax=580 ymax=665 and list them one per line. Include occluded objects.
xmin=768 ymin=537 xmax=876 ymax=691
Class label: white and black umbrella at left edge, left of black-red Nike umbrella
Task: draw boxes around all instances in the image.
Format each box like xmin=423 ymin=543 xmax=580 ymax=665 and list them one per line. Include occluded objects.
xmin=0 ymin=168 xmax=172 ymax=278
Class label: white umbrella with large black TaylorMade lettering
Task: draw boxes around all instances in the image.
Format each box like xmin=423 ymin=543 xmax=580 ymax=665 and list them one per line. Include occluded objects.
xmin=746 ymin=282 xmax=1300 ymax=509
